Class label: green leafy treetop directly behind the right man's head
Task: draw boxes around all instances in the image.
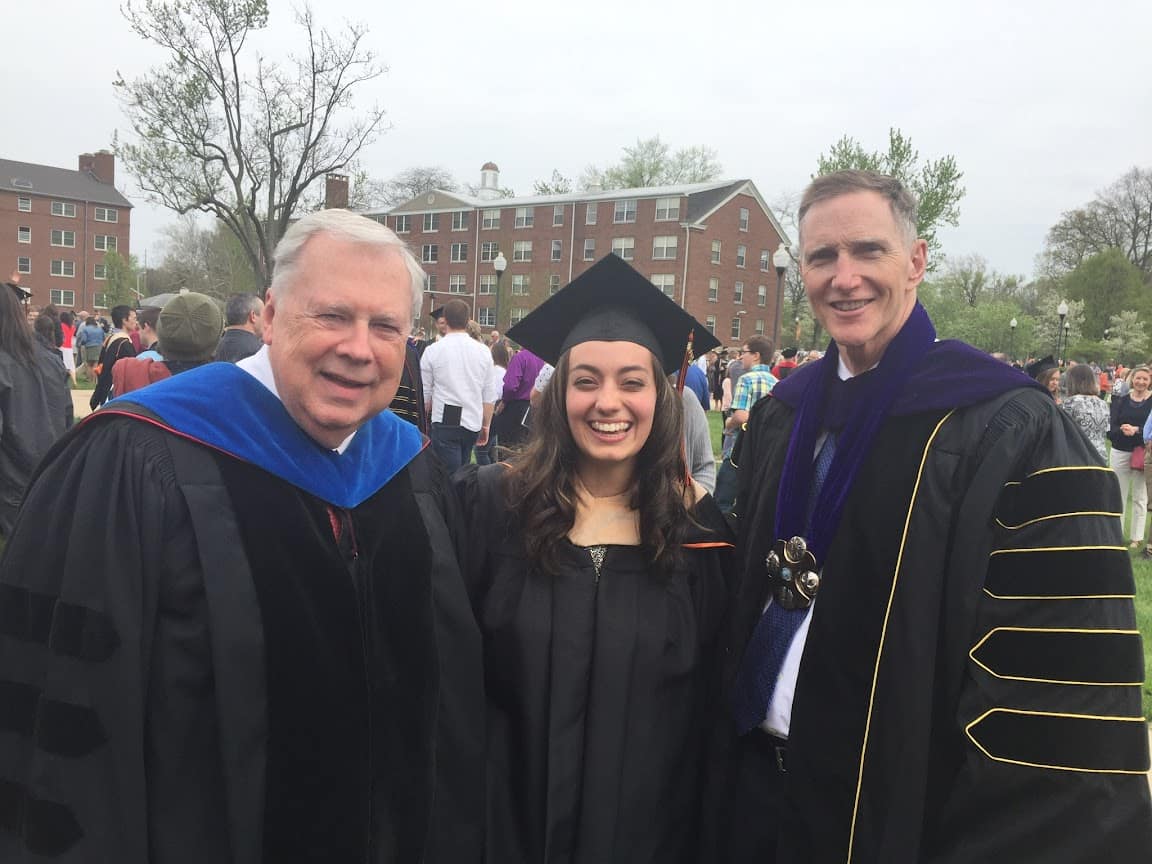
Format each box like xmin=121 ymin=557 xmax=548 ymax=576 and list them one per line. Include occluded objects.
xmin=816 ymin=128 xmax=967 ymax=262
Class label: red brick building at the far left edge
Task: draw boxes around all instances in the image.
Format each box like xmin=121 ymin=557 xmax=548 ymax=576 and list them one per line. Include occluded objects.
xmin=0 ymin=150 xmax=132 ymax=310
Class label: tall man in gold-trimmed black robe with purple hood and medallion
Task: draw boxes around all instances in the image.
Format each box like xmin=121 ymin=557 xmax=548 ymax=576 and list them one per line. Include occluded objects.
xmin=718 ymin=172 xmax=1152 ymax=864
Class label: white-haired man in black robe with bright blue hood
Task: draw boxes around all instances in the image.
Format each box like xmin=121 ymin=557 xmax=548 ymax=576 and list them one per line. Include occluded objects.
xmin=0 ymin=211 xmax=484 ymax=864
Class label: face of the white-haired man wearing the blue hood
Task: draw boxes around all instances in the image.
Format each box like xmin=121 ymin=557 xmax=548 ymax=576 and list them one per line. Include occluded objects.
xmin=263 ymin=233 xmax=412 ymax=448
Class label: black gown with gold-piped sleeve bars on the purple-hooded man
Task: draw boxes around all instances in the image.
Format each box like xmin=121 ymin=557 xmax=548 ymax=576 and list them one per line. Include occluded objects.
xmin=720 ymin=389 xmax=1152 ymax=864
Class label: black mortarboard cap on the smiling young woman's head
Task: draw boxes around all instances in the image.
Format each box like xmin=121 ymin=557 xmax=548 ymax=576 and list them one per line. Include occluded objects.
xmin=507 ymin=249 xmax=720 ymax=373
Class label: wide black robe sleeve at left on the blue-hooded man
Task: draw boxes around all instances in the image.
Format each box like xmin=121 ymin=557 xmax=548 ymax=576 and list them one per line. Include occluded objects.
xmin=0 ymin=420 xmax=230 ymax=864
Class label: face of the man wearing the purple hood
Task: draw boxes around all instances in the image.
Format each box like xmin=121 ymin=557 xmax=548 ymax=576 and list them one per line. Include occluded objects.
xmin=801 ymin=191 xmax=927 ymax=373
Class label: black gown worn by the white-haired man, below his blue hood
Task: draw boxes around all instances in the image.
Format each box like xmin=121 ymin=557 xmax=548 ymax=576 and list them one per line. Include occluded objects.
xmin=0 ymin=403 xmax=483 ymax=864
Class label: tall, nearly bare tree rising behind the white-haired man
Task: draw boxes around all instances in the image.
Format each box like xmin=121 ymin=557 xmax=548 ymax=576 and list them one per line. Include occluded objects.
xmin=114 ymin=0 xmax=384 ymax=286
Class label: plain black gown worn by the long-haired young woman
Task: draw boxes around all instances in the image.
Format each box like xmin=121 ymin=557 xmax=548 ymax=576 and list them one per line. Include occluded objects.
xmin=456 ymin=465 xmax=729 ymax=864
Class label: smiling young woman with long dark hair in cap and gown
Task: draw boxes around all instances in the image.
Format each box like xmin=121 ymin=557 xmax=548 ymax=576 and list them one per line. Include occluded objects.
xmin=456 ymin=257 xmax=730 ymax=864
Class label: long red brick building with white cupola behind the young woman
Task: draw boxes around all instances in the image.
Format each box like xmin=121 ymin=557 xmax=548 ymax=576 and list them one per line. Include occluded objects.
xmin=365 ymin=162 xmax=789 ymax=346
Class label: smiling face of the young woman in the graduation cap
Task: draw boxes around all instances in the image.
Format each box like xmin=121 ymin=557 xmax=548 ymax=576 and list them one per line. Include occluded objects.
xmin=564 ymin=342 xmax=657 ymax=482
